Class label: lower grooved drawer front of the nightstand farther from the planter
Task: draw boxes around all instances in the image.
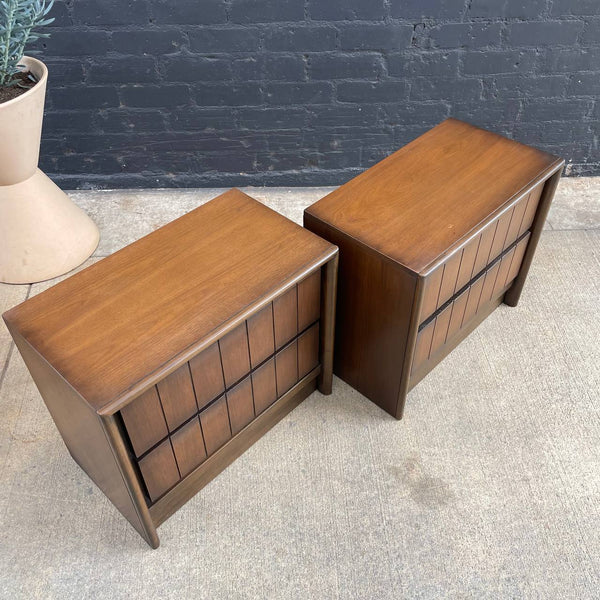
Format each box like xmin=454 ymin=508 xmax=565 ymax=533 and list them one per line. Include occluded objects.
xmin=411 ymin=233 xmax=530 ymax=373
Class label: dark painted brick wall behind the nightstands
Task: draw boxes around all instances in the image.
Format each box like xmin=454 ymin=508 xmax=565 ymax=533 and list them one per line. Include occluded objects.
xmin=34 ymin=0 xmax=600 ymax=188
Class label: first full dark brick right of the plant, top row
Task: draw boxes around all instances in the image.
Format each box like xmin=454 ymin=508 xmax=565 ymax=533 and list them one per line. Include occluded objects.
xmin=73 ymin=0 xmax=149 ymax=25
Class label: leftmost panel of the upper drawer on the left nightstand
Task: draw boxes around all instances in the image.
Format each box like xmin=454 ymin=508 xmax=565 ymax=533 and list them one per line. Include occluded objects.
xmin=121 ymin=386 xmax=167 ymax=456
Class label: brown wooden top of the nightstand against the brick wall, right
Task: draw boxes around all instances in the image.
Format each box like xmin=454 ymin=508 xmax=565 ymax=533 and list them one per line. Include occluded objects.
xmin=306 ymin=119 xmax=563 ymax=274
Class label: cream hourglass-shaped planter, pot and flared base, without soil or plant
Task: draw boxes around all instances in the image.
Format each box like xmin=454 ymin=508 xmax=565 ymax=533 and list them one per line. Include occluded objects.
xmin=0 ymin=57 xmax=99 ymax=283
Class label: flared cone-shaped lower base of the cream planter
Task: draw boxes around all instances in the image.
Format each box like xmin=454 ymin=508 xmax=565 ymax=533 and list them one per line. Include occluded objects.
xmin=0 ymin=169 xmax=100 ymax=283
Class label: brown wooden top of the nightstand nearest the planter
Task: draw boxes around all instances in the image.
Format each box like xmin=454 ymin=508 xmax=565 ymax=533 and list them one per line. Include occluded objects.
xmin=4 ymin=189 xmax=337 ymax=413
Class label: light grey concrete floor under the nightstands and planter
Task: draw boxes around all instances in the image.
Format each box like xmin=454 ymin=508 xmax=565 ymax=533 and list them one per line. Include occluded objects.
xmin=0 ymin=178 xmax=600 ymax=599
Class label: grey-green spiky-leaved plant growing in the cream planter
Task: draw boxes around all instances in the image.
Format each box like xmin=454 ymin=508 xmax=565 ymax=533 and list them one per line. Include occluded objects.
xmin=0 ymin=0 xmax=54 ymax=86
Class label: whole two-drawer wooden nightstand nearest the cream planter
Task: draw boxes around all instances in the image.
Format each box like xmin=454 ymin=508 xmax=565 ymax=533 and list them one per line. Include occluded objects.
xmin=4 ymin=190 xmax=337 ymax=548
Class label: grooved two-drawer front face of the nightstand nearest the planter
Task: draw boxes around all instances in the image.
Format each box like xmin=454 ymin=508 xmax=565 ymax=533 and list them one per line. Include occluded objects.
xmin=121 ymin=269 xmax=321 ymax=502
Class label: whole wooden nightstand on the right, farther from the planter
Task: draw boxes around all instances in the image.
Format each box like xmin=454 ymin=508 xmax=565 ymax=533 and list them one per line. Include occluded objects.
xmin=304 ymin=119 xmax=564 ymax=418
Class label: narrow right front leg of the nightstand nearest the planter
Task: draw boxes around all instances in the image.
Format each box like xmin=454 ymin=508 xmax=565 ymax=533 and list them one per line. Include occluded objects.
xmin=317 ymin=254 xmax=339 ymax=395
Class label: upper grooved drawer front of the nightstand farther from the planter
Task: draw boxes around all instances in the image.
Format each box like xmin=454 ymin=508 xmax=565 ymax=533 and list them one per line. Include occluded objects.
xmin=420 ymin=182 xmax=545 ymax=323
